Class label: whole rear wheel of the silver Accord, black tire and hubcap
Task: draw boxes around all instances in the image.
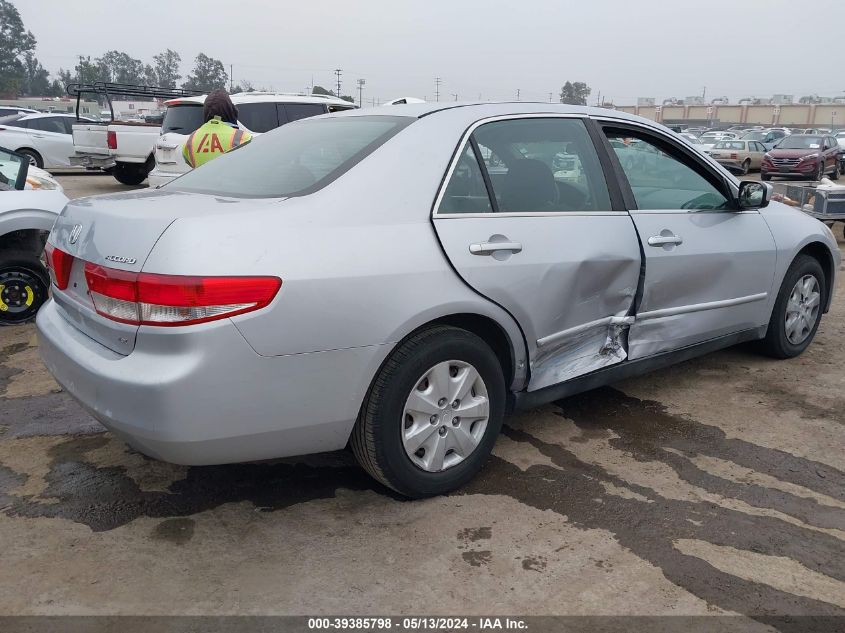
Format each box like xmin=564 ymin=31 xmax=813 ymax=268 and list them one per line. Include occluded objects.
xmin=351 ymin=326 xmax=505 ymax=498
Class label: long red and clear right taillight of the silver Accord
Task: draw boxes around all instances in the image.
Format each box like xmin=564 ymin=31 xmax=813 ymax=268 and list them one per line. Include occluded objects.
xmin=85 ymin=263 xmax=282 ymax=326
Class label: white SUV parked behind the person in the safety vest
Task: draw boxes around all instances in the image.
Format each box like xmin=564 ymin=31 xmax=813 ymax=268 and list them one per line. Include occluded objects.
xmin=149 ymin=92 xmax=356 ymax=187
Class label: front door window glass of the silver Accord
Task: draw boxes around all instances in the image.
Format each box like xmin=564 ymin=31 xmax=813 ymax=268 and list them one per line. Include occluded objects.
xmin=606 ymin=130 xmax=730 ymax=210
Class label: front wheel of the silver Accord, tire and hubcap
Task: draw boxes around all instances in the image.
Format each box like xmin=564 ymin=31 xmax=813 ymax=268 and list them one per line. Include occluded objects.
xmin=763 ymin=255 xmax=827 ymax=358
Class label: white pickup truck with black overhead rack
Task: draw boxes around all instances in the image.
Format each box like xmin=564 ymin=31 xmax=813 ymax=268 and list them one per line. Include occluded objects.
xmin=67 ymin=82 xmax=199 ymax=185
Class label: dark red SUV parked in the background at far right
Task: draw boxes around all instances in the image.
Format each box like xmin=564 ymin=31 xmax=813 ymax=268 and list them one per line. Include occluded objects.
xmin=760 ymin=134 xmax=840 ymax=180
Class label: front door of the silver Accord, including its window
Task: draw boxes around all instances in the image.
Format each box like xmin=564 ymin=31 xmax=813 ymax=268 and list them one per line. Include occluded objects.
xmin=604 ymin=123 xmax=775 ymax=359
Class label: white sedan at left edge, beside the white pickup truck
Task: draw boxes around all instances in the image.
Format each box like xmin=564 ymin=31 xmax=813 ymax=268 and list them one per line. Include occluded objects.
xmin=0 ymin=114 xmax=90 ymax=169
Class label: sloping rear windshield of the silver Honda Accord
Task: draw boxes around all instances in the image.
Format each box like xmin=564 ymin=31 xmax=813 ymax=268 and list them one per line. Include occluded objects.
xmin=166 ymin=116 xmax=414 ymax=198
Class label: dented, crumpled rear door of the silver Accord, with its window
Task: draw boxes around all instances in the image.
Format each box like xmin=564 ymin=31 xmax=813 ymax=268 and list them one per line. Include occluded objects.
xmin=434 ymin=115 xmax=641 ymax=390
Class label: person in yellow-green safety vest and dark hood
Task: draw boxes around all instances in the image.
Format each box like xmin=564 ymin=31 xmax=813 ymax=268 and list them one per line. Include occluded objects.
xmin=182 ymin=90 xmax=252 ymax=167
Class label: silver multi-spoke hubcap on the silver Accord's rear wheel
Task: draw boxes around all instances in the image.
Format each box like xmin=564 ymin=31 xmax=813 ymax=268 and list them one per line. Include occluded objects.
xmin=402 ymin=360 xmax=490 ymax=472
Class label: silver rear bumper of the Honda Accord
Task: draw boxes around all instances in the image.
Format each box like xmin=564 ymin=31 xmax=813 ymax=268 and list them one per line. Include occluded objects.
xmin=37 ymin=300 xmax=385 ymax=465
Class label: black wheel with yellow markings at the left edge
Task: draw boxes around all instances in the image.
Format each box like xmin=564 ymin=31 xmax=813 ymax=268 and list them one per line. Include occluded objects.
xmin=0 ymin=251 xmax=50 ymax=325
